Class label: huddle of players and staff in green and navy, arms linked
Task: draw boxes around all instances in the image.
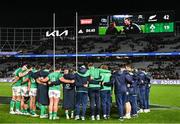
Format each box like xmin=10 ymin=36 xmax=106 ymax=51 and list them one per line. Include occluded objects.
xmin=10 ymin=63 xmax=151 ymax=120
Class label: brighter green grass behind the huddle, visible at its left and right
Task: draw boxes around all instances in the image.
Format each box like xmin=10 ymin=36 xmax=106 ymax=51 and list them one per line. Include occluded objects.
xmin=0 ymin=83 xmax=180 ymax=107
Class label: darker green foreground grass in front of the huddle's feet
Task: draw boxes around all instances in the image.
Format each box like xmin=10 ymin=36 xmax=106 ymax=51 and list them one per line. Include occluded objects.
xmin=0 ymin=105 xmax=180 ymax=123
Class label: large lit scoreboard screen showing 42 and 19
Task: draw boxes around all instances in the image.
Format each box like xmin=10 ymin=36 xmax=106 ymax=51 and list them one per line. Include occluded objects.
xmin=78 ymin=11 xmax=174 ymax=36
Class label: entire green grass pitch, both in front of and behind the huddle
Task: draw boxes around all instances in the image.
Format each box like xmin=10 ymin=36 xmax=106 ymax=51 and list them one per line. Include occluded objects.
xmin=0 ymin=83 xmax=180 ymax=123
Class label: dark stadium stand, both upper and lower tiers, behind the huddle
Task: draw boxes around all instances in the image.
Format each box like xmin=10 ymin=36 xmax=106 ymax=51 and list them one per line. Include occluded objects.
xmin=0 ymin=29 xmax=180 ymax=79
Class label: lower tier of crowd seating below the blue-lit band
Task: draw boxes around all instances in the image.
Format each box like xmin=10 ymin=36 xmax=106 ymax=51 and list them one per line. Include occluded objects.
xmin=0 ymin=57 xmax=180 ymax=79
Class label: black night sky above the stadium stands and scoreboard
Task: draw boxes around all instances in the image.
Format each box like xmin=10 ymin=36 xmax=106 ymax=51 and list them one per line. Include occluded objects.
xmin=0 ymin=0 xmax=180 ymax=27
